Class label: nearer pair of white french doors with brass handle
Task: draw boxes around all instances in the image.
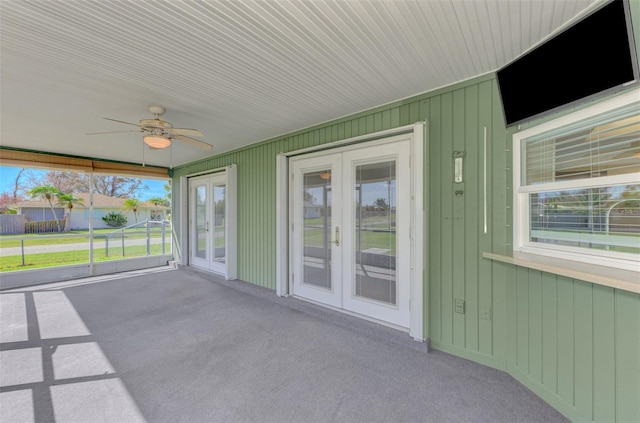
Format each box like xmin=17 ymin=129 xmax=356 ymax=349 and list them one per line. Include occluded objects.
xmin=290 ymin=140 xmax=411 ymax=328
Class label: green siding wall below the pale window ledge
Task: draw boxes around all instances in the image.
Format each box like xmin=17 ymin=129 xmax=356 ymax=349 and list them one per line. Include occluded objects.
xmin=506 ymin=266 xmax=640 ymax=423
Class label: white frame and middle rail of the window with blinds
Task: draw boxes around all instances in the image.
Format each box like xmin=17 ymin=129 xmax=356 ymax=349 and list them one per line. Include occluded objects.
xmin=512 ymin=90 xmax=640 ymax=271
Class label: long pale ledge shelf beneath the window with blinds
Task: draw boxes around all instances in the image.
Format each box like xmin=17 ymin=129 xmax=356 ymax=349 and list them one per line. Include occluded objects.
xmin=482 ymin=252 xmax=640 ymax=294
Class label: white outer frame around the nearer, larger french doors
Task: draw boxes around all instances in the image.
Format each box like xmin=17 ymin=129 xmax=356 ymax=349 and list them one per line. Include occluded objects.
xmin=276 ymin=122 xmax=426 ymax=342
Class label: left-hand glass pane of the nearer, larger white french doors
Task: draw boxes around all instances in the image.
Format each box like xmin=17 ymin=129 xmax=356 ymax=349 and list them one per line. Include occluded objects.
xmin=302 ymin=170 xmax=331 ymax=289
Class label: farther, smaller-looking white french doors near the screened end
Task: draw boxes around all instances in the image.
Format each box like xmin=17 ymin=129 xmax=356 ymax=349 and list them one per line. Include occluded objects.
xmin=189 ymin=166 xmax=236 ymax=279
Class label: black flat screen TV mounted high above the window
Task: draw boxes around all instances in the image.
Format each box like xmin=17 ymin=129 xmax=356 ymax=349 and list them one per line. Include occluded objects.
xmin=497 ymin=0 xmax=640 ymax=126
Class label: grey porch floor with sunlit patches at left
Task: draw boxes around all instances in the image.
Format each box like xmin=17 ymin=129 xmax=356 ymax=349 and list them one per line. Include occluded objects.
xmin=0 ymin=267 xmax=567 ymax=423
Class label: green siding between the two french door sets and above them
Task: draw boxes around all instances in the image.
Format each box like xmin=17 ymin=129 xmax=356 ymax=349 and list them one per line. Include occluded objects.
xmin=172 ymin=78 xmax=460 ymax=290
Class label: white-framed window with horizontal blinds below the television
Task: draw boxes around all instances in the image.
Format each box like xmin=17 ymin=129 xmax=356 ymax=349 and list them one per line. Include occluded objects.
xmin=514 ymin=91 xmax=640 ymax=270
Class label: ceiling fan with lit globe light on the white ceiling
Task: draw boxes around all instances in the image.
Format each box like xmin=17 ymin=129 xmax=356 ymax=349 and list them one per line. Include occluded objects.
xmin=87 ymin=105 xmax=213 ymax=150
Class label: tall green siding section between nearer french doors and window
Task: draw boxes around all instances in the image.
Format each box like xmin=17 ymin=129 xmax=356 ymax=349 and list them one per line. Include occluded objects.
xmin=427 ymin=80 xmax=510 ymax=368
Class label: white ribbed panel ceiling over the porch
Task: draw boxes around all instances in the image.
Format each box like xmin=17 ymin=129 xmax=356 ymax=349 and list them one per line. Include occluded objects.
xmin=0 ymin=0 xmax=596 ymax=166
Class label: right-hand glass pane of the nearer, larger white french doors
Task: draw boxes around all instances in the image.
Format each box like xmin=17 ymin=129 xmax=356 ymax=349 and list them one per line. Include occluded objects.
xmin=353 ymin=161 xmax=396 ymax=305
